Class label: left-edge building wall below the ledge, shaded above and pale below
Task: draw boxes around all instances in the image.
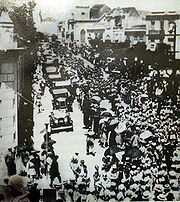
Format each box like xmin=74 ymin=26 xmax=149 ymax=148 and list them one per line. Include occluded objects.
xmin=0 ymin=50 xmax=24 ymax=151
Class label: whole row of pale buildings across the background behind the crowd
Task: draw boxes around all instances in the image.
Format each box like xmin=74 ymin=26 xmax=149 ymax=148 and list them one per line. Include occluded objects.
xmin=58 ymin=4 xmax=180 ymax=59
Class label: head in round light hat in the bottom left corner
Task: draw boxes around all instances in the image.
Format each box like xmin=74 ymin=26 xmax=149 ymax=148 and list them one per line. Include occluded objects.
xmin=8 ymin=175 xmax=24 ymax=197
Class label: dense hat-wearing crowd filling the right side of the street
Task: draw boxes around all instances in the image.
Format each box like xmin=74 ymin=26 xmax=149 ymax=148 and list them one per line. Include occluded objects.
xmin=64 ymin=42 xmax=180 ymax=201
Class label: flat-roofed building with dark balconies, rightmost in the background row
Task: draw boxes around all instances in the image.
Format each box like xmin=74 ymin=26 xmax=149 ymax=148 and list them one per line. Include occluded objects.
xmin=146 ymin=11 xmax=180 ymax=59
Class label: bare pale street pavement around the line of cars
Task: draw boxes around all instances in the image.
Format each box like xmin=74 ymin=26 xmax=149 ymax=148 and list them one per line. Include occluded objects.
xmin=34 ymin=52 xmax=104 ymax=189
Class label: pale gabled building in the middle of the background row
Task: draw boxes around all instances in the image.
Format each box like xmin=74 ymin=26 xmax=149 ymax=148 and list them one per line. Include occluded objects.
xmin=104 ymin=7 xmax=146 ymax=46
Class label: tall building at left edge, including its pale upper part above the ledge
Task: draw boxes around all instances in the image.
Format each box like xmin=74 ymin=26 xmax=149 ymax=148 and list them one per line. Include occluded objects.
xmin=0 ymin=11 xmax=24 ymax=152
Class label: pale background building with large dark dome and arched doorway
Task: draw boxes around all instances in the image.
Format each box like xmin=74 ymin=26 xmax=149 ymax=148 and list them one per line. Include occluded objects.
xmin=59 ymin=4 xmax=111 ymax=45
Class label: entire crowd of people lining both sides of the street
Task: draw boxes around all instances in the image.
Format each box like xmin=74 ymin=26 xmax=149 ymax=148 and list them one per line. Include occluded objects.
xmin=0 ymin=39 xmax=180 ymax=201
